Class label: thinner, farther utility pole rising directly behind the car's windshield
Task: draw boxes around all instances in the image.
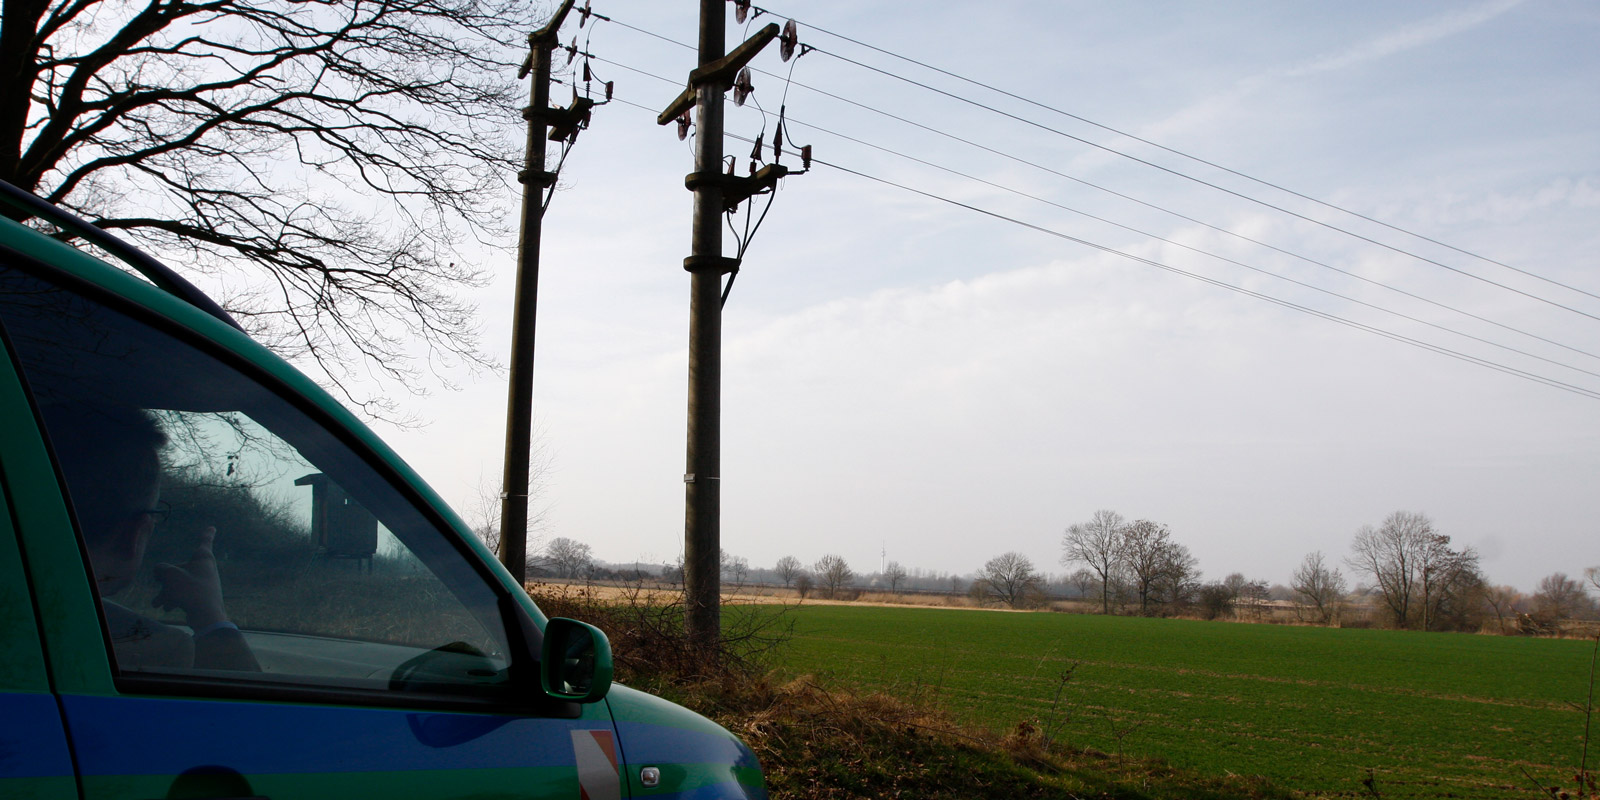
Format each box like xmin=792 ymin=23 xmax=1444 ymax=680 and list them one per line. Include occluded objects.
xmin=499 ymin=0 xmax=592 ymax=582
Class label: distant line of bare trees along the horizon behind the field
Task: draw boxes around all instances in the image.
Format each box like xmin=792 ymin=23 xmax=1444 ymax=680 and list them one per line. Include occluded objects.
xmin=505 ymin=510 xmax=1600 ymax=634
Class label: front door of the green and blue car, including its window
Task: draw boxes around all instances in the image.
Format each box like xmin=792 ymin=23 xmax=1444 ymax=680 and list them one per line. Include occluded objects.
xmin=0 ymin=228 xmax=622 ymax=800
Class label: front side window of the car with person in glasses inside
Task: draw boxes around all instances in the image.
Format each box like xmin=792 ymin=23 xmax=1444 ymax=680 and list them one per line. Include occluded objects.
xmin=0 ymin=252 xmax=509 ymax=693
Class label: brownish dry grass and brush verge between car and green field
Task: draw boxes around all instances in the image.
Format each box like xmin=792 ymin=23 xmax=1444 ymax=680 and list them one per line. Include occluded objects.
xmin=530 ymin=584 xmax=1293 ymax=800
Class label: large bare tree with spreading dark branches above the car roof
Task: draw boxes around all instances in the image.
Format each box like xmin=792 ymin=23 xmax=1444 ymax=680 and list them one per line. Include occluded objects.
xmin=0 ymin=0 xmax=536 ymax=414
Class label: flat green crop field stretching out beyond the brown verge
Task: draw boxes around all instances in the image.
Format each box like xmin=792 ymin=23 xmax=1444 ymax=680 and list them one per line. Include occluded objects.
xmin=752 ymin=606 xmax=1600 ymax=797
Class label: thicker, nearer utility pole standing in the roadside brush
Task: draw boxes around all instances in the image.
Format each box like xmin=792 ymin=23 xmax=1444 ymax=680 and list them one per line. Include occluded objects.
xmin=656 ymin=6 xmax=778 ymax=653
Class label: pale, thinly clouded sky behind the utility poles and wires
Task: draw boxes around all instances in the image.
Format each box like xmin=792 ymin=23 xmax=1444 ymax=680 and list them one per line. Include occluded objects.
xmin=379 ymin=0 xmax=1600 ymax=590
